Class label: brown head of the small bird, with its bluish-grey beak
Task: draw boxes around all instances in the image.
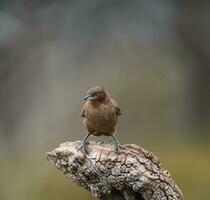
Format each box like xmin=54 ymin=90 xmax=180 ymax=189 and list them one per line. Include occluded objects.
xmin=84 ymin=86 xmax=109 ymax=101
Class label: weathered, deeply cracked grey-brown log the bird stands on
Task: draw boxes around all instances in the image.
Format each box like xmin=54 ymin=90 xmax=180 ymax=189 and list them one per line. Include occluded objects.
xmin=46 ymin=141 xmax=183 ymax=200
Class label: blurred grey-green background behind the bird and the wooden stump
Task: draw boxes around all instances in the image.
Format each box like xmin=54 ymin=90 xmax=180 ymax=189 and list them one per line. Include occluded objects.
xmin=0 ymin=0 xmax=210 ymax=200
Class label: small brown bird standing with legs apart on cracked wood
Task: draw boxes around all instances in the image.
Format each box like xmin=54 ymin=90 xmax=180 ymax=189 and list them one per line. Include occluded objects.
xmin=78 ymin=86 xmax=122 ymax=153
